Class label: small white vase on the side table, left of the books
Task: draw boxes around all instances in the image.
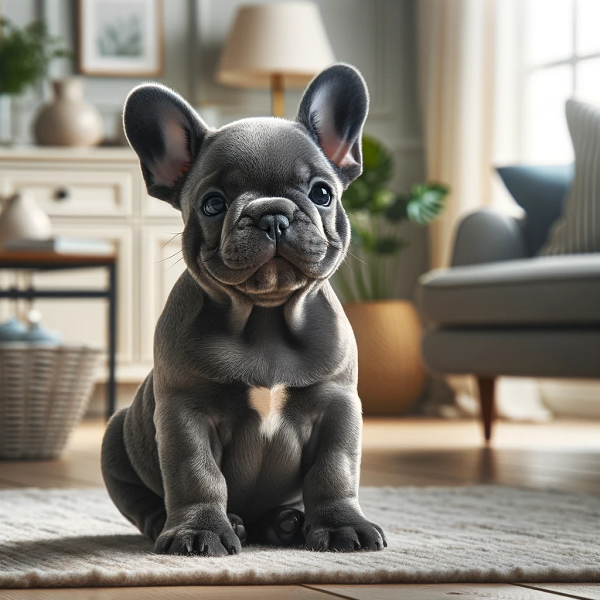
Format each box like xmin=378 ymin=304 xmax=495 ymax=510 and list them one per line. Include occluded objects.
xmin=0 ymin=191 xmax=52 ymax=248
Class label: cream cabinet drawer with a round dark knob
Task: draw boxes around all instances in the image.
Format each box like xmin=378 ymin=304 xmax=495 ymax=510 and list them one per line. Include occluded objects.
xmin=2 ymin=164 xmax=134 ymax=217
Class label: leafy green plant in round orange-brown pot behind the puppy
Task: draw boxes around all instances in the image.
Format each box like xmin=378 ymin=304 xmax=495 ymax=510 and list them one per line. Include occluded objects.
xmin=334 ymin=136 xmax=449 ymax=415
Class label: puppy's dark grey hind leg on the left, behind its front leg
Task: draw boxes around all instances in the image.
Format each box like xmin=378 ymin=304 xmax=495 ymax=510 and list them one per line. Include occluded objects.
xmin=102 ymin=408 xmax=167 ymax=541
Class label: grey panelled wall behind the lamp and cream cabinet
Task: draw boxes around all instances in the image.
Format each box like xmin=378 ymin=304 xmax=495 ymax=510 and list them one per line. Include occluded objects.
xmin=0 ymin=0 xmax=428 ymax=297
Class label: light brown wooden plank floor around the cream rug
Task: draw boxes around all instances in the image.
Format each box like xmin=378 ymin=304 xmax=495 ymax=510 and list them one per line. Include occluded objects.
xmin=0 ymin=420 xmax=600 ymax=600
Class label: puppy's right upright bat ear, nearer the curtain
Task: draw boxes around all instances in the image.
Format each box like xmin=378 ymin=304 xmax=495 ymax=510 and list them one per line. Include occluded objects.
xmin=297 ymin=64 xmax=369 ymax=185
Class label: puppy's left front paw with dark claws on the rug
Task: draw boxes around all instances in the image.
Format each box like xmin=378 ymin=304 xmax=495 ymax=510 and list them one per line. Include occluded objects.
xmin=154 ymin=522 xmax=242 ymax=556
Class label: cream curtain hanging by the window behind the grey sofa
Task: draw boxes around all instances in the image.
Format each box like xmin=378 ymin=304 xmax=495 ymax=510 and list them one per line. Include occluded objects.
xmin=417 ymin=0 xmax=550 ymax=420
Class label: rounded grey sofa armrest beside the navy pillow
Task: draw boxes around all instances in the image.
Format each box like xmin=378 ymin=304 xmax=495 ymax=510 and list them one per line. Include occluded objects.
xmin=452 ymin=209 xmax=528 ymax=267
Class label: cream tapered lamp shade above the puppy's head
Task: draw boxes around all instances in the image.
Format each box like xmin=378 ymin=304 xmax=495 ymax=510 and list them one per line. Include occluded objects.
xmin=217 ymin=2 xmax=335 ymax=87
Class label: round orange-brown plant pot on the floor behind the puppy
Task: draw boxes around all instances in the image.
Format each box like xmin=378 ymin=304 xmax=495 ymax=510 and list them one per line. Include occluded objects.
xmin=344 ymin=300 xmax=425 ymax=416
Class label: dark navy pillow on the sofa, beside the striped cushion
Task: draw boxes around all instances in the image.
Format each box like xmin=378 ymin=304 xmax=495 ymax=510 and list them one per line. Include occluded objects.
xmin=496 ymin=165 xmax=574 ymax=256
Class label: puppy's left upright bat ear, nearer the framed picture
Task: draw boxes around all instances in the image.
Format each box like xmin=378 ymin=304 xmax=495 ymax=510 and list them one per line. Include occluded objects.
xmin=123 ymin=83 xmax=208 ymax=209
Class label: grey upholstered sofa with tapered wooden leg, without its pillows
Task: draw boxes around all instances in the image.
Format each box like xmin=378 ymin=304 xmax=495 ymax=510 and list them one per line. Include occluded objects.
xmin=417 ymin=210 xmax=600 ymax=441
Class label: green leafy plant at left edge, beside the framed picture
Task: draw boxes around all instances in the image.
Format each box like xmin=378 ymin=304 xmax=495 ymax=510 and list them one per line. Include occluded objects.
xmin=0 ymin=19 xmax=71 ymax=143
